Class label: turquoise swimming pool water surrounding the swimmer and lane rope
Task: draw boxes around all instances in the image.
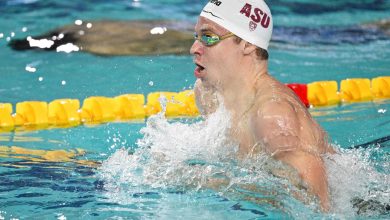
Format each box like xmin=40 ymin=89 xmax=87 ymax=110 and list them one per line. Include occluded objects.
xmin=0 ymin=0 xmax=390 ymax=219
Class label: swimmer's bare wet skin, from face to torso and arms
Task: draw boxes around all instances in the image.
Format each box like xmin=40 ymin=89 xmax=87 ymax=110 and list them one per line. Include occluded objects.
xmin=191 ymin=17 xmax=334 ymax=211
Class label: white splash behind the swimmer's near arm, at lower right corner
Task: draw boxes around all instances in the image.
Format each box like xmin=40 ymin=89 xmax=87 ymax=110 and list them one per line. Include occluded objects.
xmin=325 ymin=148 xmax=390 ymax=216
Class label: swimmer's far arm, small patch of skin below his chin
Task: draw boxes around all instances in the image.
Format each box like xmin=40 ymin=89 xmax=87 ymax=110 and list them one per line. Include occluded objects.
xmin=194 ymin=79 xmax=218 ymax=116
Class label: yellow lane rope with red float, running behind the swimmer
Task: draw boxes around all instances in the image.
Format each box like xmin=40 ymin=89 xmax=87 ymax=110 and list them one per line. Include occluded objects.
xmin=0 ymin=76 xmax=390 ymax=131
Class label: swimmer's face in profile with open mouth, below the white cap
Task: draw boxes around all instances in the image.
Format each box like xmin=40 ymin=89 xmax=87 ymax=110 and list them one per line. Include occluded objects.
xmin=190 ymin=17 xmax=239 ymax=89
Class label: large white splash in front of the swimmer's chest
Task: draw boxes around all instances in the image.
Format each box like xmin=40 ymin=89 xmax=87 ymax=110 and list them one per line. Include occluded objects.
xmin=100 ymin=104 xmax=237 ymax=188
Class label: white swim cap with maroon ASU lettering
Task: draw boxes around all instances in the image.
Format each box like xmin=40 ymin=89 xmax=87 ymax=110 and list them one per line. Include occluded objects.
xmin=200 ymin=0 xmax=273 ymax=50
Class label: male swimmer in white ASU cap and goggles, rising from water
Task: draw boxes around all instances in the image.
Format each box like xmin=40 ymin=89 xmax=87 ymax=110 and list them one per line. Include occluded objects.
xmin=190 ymin=0 xmax=334 ymax=211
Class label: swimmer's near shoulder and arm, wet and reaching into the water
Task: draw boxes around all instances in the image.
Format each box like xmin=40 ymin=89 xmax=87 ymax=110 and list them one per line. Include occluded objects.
xmin=254 ymin=102 xmax=329 ymax=211
